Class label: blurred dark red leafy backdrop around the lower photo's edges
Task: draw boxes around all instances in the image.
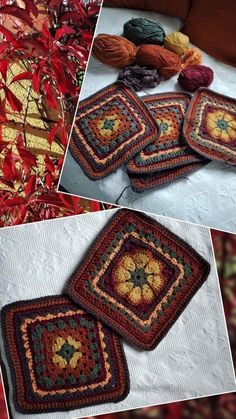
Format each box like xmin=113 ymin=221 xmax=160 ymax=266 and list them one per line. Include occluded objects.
xmin=0 ymin=230 xmax=236 ymax=419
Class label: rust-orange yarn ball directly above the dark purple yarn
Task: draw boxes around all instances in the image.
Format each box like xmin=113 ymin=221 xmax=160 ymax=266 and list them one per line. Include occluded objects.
xmin=136 ymin=45 xmax=181 ymax=80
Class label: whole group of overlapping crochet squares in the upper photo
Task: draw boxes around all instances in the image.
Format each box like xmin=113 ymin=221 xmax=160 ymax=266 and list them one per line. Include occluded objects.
xmin=70 ymin=83 xmax=236 ymax=192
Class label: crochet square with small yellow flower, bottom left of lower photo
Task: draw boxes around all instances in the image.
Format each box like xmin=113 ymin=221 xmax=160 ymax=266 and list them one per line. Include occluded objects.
xmin=2 ymin=296 xmax=129 ymax=413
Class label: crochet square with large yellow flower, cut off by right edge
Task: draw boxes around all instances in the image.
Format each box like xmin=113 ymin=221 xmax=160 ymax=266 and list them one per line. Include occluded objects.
xmin=183 ymin=89 xmax=236 ymax=165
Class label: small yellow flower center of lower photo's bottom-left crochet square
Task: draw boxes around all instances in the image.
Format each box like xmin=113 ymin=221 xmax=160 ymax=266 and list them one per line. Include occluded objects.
xmin=52 ymin=336 xmax=82 ymax=368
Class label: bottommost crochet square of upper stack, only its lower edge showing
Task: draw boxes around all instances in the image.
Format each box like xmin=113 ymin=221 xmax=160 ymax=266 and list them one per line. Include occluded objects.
xmin=129 ymin=163 xmax=206 ymax=192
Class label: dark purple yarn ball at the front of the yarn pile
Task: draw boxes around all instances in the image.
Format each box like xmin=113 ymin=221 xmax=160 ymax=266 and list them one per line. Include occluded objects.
xmin=117 ymin=65 xmax=161 ymax=92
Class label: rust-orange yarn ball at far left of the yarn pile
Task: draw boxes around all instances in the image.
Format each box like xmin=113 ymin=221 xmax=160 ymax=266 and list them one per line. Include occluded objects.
xmin=92 ymin=34 xmax=137 ymax=68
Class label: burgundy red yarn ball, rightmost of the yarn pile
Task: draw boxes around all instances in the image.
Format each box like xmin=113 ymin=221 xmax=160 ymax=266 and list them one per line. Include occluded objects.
xmin=178 ymin=65 xmax=214 ymax=92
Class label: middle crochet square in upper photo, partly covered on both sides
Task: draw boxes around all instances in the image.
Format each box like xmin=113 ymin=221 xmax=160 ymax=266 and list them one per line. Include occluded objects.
xmin=127 ymin=92 xmax=202 ymax=174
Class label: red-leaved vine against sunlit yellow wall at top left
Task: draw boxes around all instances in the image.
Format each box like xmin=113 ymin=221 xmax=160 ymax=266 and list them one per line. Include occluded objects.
xmin=0 ymin=0 xmax=101 ymax=226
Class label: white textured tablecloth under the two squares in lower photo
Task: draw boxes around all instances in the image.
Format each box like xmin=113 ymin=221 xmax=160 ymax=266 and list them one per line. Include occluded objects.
xmin=0 ymin=210 xmax=236 ymax=419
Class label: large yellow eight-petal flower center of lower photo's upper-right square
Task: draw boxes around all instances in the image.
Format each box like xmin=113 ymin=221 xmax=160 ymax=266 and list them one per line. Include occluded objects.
xmin=113 ymin=251 xmax=163 ymax=305
